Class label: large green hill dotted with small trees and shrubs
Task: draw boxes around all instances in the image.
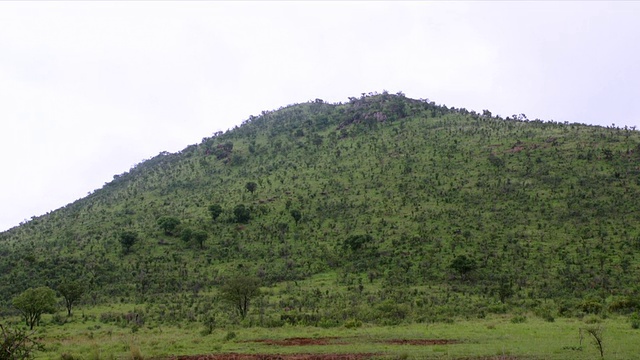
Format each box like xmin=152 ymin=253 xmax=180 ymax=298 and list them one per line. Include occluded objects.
xmin=0 ymin=93 xmax=640 ymax=323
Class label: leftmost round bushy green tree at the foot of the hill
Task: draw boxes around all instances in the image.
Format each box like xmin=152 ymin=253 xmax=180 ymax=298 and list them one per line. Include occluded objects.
xmin=13 ymin=286 xmax=56 ymax=330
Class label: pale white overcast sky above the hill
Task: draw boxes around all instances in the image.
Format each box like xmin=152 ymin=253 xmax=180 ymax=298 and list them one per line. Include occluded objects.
xmin=0 ymin=1 xmax=640 ymax=231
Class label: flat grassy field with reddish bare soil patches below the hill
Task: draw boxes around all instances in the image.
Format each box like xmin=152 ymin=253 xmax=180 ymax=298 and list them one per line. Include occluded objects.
xmin=13 ymin=309 xmax=640 ymax=360
